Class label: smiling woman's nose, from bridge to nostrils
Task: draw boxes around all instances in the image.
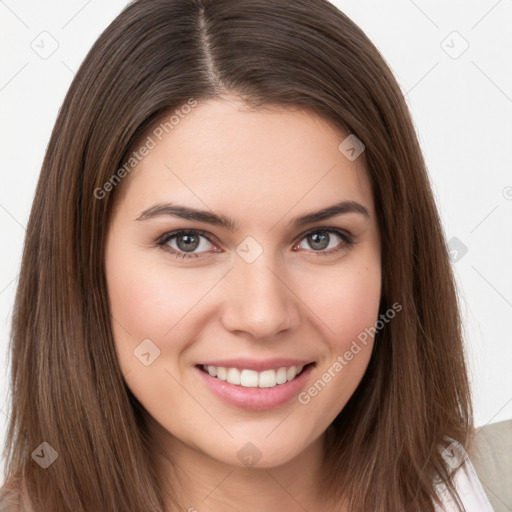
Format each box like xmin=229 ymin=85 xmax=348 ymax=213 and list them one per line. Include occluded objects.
xmin=222 ymin=252 xmax=301 ymax=340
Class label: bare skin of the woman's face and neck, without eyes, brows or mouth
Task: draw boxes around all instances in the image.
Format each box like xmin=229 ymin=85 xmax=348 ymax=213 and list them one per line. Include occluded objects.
xmin=105 ymin=96 xmax=381 ymax=512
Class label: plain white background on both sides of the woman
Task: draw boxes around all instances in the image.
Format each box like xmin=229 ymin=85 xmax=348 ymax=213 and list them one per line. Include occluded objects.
xmin=0 ymin=0 xmax=512 ymax=480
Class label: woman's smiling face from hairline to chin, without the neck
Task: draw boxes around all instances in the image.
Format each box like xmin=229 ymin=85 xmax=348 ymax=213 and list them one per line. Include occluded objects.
xmin=105 ymin=94 xmax=381 ymax=467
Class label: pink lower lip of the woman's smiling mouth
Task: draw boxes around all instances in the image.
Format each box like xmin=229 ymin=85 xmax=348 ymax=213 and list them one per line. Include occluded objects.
xmin=195 ymin=364 xmax=315 ymax=411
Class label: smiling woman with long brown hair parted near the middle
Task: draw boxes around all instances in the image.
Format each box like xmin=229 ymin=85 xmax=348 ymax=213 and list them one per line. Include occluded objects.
xmin=0 ymin=0 xmax=491 ymax=512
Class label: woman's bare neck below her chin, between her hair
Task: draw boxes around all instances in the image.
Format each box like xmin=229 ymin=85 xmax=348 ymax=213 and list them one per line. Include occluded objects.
xmin=149 ymin=420 xmax=332 ymax=512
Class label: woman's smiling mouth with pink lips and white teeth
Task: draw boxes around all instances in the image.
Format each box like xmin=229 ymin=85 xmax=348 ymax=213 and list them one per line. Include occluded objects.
xmin=195 ymin=362 xmax=317 ymax=411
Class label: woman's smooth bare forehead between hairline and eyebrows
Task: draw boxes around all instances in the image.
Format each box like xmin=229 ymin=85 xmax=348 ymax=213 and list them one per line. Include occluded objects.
xmin=114 ymin=98 xmax=373 ymax=223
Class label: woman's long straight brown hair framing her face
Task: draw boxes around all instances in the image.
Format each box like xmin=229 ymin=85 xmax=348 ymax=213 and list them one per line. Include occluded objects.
xmin=0 ymin=0 xmax=472 ymax=512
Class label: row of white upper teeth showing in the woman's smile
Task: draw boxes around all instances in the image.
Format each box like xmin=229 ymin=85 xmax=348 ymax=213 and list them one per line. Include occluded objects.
xmin=203 ymin=365 xmax=304 ymax=388
